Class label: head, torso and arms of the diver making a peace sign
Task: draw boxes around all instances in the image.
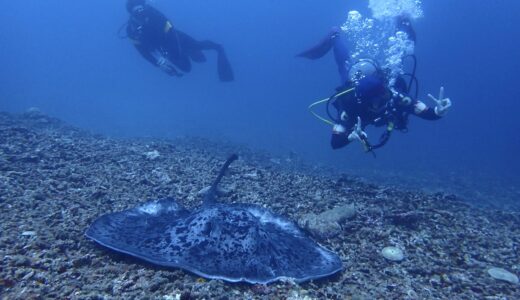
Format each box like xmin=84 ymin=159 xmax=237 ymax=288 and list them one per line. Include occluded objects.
xmin=331 ymin=60 xmax=451 ymax=151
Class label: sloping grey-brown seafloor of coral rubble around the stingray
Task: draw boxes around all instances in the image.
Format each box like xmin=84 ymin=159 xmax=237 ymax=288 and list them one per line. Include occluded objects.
xmin=0 ymin=112 xmax=520 ymax=299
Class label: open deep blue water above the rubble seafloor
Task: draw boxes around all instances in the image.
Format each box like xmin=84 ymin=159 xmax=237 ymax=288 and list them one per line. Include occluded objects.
xmin=0 ymin=0 xmax=520 ymax=202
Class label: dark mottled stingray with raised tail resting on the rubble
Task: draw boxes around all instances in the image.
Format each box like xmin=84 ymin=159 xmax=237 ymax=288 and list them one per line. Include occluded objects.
xmin=85 ymin=155 xmax=342 ymax=284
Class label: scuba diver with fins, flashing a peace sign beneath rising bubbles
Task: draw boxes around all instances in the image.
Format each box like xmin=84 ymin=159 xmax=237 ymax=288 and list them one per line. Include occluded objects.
xmin=297 ymin=17 xmax=451 ymax=153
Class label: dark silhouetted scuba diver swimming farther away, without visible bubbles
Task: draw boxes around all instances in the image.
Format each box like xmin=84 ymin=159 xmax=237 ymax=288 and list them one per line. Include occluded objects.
xmin=126 ymin=0 xmax=234 ymax=81
